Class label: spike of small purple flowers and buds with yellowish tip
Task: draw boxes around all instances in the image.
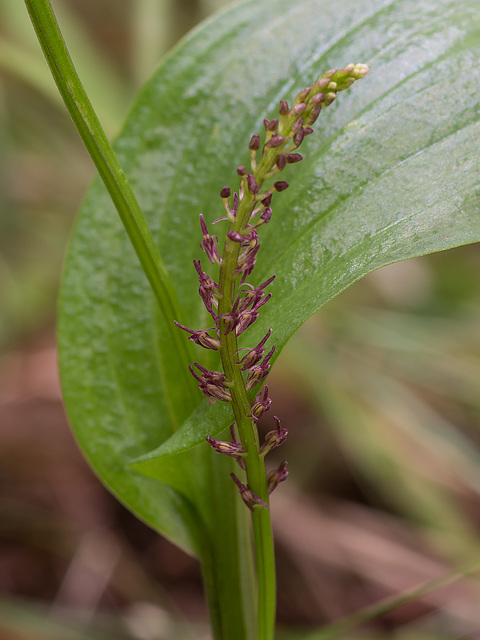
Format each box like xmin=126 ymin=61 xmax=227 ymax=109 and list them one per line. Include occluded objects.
xmin=176 ymin=64 xmax=368 ymax=510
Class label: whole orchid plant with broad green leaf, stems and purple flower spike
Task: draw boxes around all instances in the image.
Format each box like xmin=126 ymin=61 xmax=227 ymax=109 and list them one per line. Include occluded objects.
xmin=25 ymin=0 xmax=480 ymax=640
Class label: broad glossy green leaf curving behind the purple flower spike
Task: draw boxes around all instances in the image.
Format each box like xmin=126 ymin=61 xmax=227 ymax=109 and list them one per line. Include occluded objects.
xmin=59 ymin=0 xmax=480 ymax=576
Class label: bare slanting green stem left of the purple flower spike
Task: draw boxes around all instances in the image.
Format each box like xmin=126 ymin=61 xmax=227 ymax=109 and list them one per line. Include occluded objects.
xmin=25 ymin=0 xmax=196 ymax=408
